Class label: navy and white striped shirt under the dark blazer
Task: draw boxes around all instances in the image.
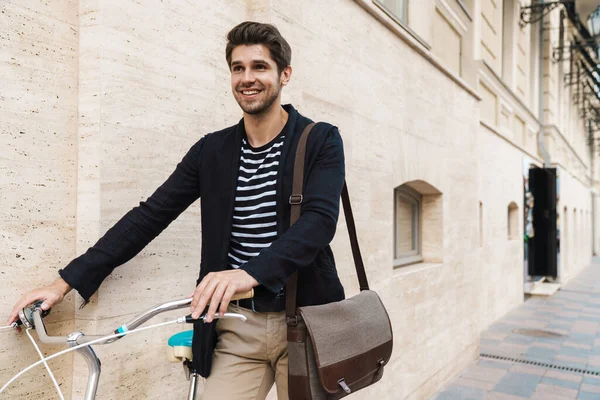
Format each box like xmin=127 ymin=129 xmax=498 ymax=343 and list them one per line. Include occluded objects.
xmin=227 ymin=132 xmax=285 ymax=268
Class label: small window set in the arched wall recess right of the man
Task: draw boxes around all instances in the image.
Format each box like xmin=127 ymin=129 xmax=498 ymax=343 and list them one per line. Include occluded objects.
xmin=394 ymin=185 xmax=422 ymax=264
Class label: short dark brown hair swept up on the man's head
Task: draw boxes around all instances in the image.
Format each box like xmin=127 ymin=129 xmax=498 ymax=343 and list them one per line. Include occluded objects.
xmin=225 ymin=21 xmax=292 ymax=74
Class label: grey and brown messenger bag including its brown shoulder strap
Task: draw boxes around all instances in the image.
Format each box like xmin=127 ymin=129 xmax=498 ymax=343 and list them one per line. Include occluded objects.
xmin=286 ymin=123 xmax=393 ymax=400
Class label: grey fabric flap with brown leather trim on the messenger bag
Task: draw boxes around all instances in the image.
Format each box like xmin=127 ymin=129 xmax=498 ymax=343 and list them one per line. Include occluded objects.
xmin=298 ymin=290 xmax=393 ymax=393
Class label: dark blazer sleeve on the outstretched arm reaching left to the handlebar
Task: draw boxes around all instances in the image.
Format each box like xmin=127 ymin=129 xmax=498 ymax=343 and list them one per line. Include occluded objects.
xmin=59 ymin=138 xmax=205 ymax=302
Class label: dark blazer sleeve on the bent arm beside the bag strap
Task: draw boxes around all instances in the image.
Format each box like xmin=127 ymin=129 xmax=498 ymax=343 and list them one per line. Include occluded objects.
xmin=240 ymin=127 xmax=345 ymax=293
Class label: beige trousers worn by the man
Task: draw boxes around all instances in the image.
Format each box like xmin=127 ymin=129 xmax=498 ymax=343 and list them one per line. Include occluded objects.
xmin=202 ymin=304 xmax=288 ymax=400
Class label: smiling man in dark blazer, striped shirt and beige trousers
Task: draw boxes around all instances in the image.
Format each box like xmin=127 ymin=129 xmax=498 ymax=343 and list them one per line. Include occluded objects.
xmin=8 ymin=22 xmax=344 ymax=400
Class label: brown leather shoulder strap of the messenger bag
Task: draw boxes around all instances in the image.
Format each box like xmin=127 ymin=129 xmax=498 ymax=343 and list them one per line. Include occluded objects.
xmin=285 ymin=123 xmax=369 ymax=324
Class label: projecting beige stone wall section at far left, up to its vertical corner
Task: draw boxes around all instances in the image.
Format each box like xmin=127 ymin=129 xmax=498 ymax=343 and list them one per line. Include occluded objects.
xmin=0 ymin=0 xmax=79 ymax=399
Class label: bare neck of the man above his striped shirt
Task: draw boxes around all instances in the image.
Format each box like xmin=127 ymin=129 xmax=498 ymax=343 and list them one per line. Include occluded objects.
xmin=244 ymin=103 xmax=288 ymax=147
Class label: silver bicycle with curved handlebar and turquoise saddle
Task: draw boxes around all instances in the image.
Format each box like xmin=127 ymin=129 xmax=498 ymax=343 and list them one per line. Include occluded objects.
xmin=7 ymin=291 xmax=253 ymax=400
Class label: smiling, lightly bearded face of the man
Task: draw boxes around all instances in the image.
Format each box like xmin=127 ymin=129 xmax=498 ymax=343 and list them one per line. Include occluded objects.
xmin=230 ymin=44 xmax=291 ymax=115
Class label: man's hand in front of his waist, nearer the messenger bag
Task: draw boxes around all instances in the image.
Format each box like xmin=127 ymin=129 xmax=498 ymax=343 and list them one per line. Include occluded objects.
xmin=191 ymin=269 xmax=258 ymax=322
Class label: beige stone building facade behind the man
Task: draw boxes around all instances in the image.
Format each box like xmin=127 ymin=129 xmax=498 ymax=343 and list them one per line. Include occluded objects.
xmin=0 ymin=0 xmax=600 ymax=399
